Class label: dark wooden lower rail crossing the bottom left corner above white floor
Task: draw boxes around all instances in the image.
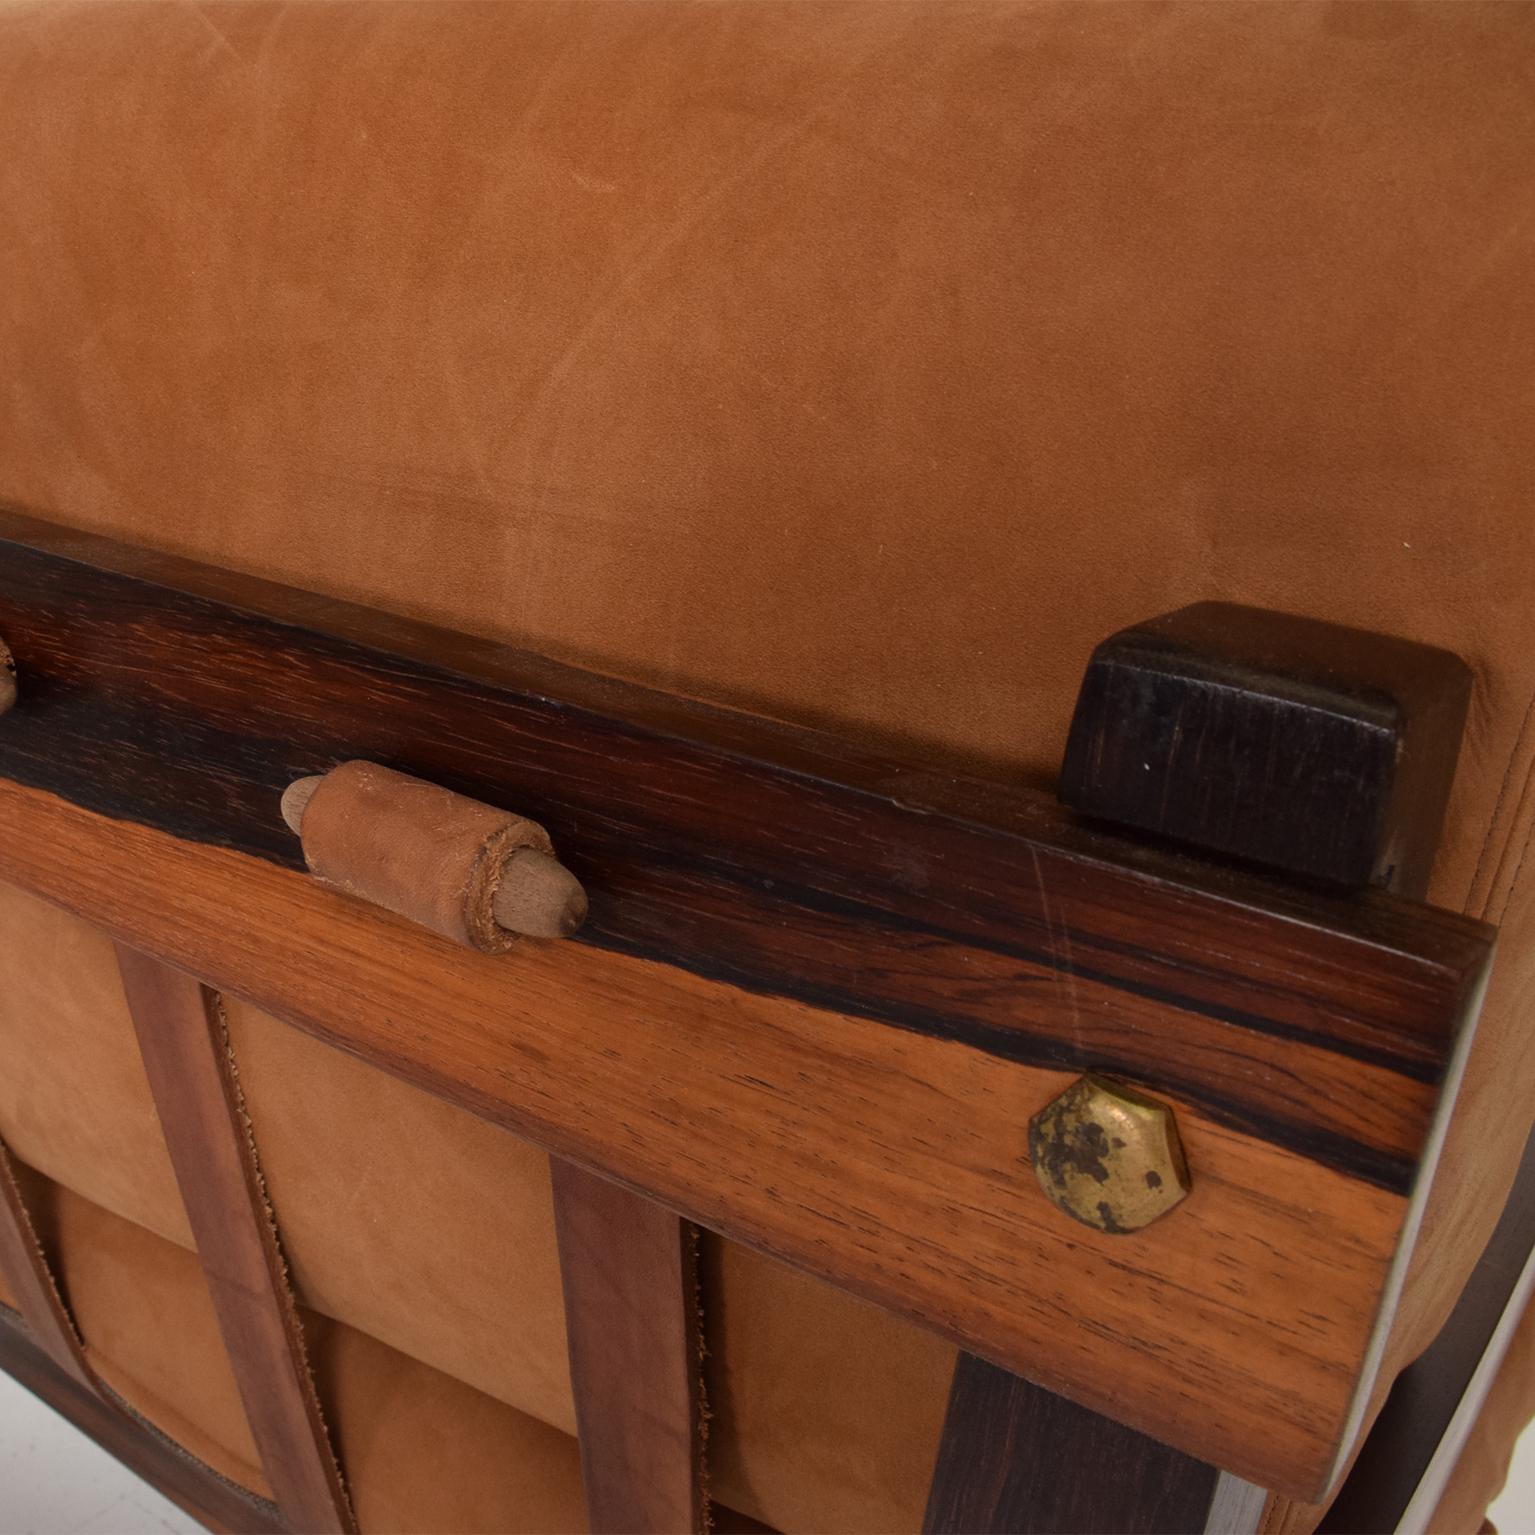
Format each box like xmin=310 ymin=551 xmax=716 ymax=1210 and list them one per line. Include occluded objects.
xmin=0 ymin=1306 xmax=289 ymax=1535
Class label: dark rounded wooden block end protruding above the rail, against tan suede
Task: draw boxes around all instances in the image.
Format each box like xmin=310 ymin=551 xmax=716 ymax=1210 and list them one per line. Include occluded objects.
xmin=1061 ymin=602 xmax=1471 ymax=895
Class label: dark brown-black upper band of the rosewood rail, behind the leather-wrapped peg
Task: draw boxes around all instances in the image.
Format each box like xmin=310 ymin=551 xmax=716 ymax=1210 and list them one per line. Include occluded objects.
xmin=0 ymin=514 xmax=1486 ymax=1193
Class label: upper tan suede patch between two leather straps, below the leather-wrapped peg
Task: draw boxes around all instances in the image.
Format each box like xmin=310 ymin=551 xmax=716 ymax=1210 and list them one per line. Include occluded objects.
xmin=226 ymin=998 xmax=576 ymax=1434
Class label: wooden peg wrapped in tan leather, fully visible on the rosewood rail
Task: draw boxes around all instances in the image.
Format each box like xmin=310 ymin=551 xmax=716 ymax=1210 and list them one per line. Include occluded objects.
xmin=282 ymin=761 xmax=586 ymax=953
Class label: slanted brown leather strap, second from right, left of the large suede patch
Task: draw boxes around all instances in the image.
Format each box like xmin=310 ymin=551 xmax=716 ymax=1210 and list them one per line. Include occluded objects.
xmin=117 ymin=944 xmax=356 ymax=1535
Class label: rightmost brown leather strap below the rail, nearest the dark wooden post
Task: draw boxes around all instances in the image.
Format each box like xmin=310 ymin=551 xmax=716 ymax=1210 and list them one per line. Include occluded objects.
xmin=550 ymin=1157 xmax=706 ymax=1535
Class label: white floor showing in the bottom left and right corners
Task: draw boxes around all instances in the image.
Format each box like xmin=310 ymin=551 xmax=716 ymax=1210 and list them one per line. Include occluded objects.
xmin=0 ymin=1372 xmax=1535 ymax=1535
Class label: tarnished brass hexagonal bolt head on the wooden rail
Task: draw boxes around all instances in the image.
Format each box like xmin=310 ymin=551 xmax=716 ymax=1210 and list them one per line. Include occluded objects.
xmin=1028 ymin=1076 xmax=1190 ymax=1234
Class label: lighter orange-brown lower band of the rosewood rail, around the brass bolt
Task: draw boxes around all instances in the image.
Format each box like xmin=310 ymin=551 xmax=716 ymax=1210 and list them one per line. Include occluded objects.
xmin=0 ymin=781 xmax=1473 ymax=1497
